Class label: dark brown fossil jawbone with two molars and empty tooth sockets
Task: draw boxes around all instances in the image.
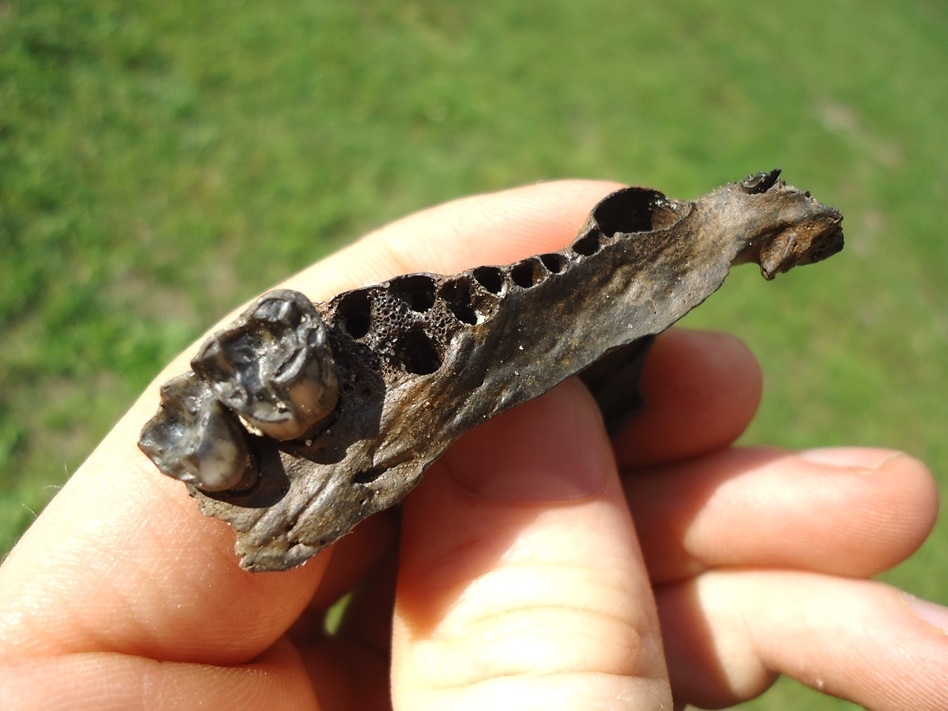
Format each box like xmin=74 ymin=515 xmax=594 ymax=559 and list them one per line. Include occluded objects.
xmin=140 ymin=171 xmax=843 ymax=571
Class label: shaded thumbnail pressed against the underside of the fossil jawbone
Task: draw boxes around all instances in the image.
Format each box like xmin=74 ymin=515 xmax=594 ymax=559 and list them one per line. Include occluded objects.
xmin=445 ymin=381 xmax=614 ymax=501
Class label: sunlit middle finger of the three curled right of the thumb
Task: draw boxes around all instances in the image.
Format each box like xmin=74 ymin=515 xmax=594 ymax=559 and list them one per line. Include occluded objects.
xmin=624 ymin=448 xmax=938 ymax=583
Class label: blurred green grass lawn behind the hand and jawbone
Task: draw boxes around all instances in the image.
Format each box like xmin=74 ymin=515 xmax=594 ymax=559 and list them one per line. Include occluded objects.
xmin=0 ymin=0 xmax=948 ymax=709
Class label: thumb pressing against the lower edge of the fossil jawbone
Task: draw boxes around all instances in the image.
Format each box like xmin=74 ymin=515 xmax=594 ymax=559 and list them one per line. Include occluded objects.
xmin=392 ymin=380 xmax=671 ymax=709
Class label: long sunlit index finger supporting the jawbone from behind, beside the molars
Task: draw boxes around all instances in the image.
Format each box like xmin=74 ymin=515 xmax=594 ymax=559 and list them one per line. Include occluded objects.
xmin=0 ymin=182 xmax=624 ymax=663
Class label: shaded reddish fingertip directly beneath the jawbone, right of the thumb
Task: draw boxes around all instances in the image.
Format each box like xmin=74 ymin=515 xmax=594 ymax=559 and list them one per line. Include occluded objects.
xmin=613 ymin=328 xmax=762 ymax=470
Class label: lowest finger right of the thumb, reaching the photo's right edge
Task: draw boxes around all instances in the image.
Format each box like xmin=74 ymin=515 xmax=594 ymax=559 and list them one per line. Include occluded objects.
xmin=656 ymin=571 xmax=948 ymax=711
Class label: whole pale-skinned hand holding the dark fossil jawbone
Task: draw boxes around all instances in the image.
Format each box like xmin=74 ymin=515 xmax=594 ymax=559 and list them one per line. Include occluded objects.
xmin=0 ymin=181 xmax=948 ymax=711
